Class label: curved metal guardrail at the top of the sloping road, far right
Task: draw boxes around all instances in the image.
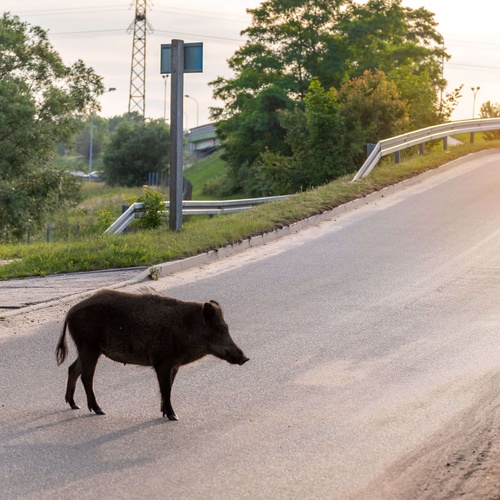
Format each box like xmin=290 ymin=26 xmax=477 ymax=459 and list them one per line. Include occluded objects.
xmin=352 ymin=118 xmax=500 ymax=181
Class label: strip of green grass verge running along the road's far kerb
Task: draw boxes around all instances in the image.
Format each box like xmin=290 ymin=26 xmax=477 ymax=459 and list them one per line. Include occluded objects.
xmin=0 ymin=138 xmax=500 ymax=279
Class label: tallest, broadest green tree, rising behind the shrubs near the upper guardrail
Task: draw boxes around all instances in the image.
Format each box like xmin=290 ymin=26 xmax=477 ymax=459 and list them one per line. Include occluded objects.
xmin=211 ymin=0 xmax=450 ymax=194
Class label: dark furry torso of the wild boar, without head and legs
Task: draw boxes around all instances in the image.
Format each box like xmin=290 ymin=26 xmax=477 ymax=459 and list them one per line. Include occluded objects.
xmin=68 ymin=290 xmax=202 ymax=366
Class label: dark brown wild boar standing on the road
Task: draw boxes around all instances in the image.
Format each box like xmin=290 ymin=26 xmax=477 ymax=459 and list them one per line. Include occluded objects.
xmin=56 ymin=290 xmax=248 ymax=420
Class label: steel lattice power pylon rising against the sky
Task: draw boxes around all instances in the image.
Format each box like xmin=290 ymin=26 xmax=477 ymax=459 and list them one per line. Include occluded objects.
xmin=128 ymin=0 xmax=153 ymax=118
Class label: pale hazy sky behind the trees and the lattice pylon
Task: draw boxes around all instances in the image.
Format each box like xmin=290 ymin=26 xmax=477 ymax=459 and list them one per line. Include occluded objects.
xmin=0 ymin=0 xmax=500 ymax=128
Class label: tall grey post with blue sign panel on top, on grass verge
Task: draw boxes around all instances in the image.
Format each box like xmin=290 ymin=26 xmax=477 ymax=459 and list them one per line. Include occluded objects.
xmin=160 ymin=40 xmax=203 ymax=231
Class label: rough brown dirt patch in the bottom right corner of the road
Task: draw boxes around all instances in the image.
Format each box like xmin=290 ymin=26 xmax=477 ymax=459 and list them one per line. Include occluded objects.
xmin=355 ymin=374 xmax=500 ymax=500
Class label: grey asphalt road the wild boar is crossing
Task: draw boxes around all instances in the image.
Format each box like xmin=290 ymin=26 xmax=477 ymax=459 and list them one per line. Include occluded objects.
xmin=0 ymin=153 xmax=500 ymax=499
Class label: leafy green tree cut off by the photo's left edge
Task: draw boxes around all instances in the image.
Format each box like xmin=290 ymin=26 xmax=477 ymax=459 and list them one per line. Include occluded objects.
xmin=0 ymin=13 xmax=104 ymax=238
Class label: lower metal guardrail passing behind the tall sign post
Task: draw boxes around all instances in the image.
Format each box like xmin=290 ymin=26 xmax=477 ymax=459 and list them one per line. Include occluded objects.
xmin=105 ymin=195 xmax=293 ymax=234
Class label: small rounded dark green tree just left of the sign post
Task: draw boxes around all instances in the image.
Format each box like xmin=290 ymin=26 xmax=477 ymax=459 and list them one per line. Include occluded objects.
xmin=103 ymin=120 xmax=170 ymax=186
